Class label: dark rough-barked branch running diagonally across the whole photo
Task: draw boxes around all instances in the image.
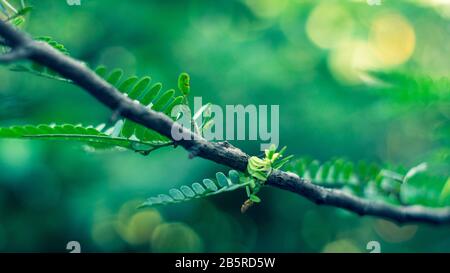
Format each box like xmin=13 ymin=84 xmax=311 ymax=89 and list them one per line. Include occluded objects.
xmin=0 ymin=21 xmax=450 ymax=224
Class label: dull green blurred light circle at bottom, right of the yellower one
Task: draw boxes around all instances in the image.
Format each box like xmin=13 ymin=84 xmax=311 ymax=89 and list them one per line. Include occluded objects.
xmin=152 ymin=223 xmax=203 ymax=252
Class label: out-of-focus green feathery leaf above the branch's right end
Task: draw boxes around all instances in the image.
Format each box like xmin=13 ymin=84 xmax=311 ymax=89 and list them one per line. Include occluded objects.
xmin=287 ymin=158 xmax=450 ymax=207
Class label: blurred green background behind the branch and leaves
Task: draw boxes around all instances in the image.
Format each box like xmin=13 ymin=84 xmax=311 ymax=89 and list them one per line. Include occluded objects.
xmin=0 ymin=0 xmax=450 ymax=252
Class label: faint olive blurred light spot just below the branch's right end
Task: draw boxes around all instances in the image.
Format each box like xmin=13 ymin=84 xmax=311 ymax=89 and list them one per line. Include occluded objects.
xmin=375 ymin=219 xmax=418 ymax=243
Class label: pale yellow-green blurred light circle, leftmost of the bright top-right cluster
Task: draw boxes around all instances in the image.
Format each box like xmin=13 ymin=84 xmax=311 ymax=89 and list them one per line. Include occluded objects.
xmin=306 ymin=2 xmax=354 ymax=48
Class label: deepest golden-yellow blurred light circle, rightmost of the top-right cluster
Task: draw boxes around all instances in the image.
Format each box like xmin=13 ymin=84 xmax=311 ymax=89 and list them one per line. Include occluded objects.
xmin=369 ymin=13 xmax=416 ymax=67
